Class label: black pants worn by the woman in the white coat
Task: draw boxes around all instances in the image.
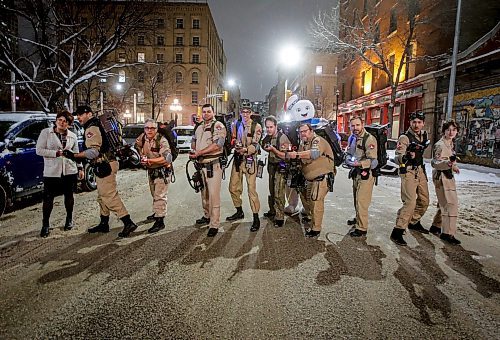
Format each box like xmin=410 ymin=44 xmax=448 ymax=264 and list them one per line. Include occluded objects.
xmin=43 ymin=174 xmax=77 ymax=226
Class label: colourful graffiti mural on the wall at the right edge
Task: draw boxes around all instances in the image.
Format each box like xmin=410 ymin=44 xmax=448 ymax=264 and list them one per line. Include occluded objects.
xmin=454 ymin=87 xmax=500 ymax=165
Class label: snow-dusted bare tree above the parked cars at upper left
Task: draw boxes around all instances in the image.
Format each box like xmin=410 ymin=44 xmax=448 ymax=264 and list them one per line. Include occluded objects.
xmin=0 ymin=0 xmax=146 ymax=112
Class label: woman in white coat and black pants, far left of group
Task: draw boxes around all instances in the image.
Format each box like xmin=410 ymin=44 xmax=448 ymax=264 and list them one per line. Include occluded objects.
xmin=36 ymin=111 xmax=83 ymax=237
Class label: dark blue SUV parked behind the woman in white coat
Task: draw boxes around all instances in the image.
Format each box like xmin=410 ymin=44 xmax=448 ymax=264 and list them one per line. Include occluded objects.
xmin=0 ymin=112 xmax=96 ymax=216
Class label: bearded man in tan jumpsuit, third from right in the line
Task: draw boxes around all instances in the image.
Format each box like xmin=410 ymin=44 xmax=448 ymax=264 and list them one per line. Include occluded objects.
xmin=346 ymin=116 xmax=378 ymax=237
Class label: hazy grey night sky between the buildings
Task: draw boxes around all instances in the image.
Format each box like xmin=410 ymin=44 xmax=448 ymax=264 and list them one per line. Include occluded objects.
xmin=208 ymin=0 xmax=336 ymax=100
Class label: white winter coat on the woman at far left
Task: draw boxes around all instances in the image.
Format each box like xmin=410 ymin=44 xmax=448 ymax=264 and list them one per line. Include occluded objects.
xmin=36 ymin=127 xmax=79 ymax=177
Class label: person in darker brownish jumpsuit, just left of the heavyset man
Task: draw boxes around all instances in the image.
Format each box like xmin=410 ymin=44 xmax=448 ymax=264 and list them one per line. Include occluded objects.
xmin=263 ymin=116 xmax=290 ymax=227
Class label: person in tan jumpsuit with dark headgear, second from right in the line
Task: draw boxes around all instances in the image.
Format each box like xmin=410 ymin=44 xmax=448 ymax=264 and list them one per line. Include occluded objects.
xmin=391 ymin=111 xmax=429 ymax=246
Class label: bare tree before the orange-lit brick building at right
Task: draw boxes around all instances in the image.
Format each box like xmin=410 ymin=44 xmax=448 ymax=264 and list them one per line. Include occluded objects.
xmin=309 ymin=0 xmax=448 ymax=128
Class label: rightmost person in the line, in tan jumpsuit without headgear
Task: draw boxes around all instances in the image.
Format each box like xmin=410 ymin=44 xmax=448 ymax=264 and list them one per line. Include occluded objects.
xmin=430 ymin=121 xmax=461 ymax=244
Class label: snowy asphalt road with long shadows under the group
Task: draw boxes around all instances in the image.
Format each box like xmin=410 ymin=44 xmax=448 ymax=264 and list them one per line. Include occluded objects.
xmin=0 ymin=155 xmax=500 ymax=339
